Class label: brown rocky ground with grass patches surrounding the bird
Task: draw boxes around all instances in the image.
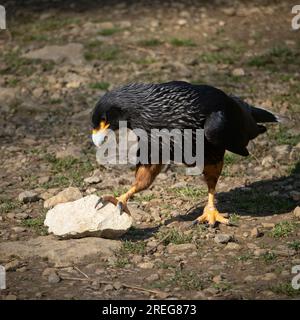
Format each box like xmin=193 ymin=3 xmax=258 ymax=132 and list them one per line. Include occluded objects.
xmin=0 ymin=1 xmax=300 ymax=299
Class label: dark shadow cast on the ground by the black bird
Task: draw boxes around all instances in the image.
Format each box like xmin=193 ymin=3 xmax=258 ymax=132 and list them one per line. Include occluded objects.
xmin=126 ymin=169 xmax=300 ymax=240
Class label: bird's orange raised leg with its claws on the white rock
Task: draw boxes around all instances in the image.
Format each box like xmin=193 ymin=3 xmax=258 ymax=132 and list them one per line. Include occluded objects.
xmin=96 ymin=164 xmax=162 ymax=214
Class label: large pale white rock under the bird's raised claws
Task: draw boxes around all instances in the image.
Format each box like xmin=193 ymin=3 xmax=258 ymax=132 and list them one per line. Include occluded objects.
xmin=44 ymin=195 xmax=133 ymax=238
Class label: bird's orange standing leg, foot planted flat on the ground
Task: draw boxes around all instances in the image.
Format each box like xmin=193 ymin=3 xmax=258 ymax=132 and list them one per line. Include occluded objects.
xmin=194 ymin=161 xmax=229 ymax=226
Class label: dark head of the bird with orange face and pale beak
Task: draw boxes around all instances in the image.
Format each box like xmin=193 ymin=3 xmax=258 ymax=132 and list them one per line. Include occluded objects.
xmin=91 ymin=94 xmax=127 ymax=147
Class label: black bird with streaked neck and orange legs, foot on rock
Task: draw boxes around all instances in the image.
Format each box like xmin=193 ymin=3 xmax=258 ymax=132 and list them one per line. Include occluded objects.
xmin=92 ymin=81 xmax=279 ymax=225
